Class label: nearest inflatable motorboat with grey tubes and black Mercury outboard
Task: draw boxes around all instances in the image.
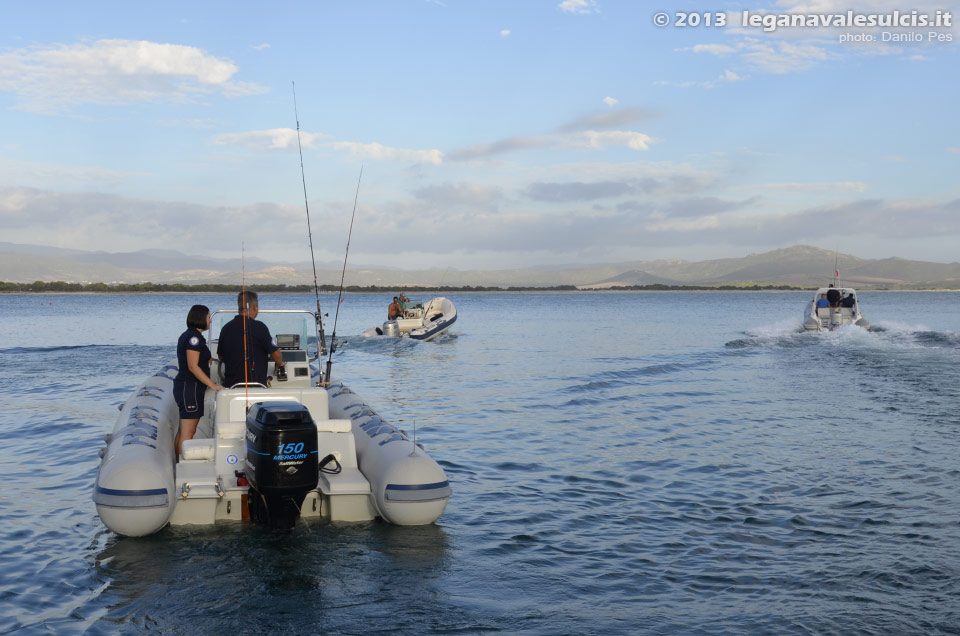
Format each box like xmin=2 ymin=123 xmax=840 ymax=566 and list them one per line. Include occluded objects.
xmin=93 ymin=310 xmax=451 ymax=536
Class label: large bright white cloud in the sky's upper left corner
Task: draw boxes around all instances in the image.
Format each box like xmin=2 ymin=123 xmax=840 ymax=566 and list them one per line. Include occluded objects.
xmin=0 ymin=39 xmax=266 ymax=112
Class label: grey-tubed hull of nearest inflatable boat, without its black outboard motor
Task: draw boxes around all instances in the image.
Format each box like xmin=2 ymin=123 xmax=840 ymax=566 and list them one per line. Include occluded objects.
xmin=93 ymin=362 xmax=451 ymax=536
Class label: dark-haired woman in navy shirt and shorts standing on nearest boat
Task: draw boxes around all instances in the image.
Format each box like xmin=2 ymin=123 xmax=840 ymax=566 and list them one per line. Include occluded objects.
xmin=173 ymin=305 xmax=223 ymax=457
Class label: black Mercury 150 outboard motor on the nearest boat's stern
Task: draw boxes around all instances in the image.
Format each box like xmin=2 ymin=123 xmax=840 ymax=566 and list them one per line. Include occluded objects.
xmin=246 ymin=402 xmax=320 ymax=528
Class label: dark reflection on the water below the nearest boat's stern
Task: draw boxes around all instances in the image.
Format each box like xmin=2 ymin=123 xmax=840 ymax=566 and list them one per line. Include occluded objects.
xmin=95 ymin=522 xmax=448 ymax=633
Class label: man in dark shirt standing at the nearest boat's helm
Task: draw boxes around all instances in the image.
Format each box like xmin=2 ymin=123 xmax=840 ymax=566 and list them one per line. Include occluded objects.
xmin=217 ymin=291 xmax=285 ymax=386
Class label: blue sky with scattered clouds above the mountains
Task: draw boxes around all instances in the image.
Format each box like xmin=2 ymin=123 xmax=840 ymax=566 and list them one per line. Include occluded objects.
xmin=0 ymin=0 xmax=960 ymax=269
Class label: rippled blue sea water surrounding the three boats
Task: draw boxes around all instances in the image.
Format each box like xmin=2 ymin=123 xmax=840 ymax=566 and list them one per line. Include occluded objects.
xmin=0 ymin=292 xmax=960 ymax=635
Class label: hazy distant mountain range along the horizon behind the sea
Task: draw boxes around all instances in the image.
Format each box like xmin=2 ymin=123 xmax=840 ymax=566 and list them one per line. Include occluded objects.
xmin=0 ymin=242 xmax=960 ymax=289
